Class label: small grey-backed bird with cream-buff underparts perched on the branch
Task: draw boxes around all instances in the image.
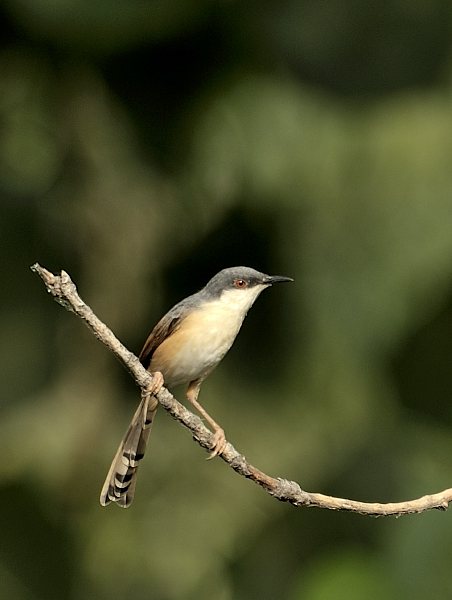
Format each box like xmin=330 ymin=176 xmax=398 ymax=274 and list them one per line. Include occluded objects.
xmin=100 ymin=267 xmax=293 ymax=508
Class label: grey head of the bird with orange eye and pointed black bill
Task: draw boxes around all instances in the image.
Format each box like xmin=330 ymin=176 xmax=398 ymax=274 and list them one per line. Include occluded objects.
xmin=202 ymin=267 xmax=293 ymax=304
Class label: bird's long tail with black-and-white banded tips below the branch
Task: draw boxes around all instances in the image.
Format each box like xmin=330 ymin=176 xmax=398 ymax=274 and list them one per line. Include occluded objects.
xmin=100 ymin=395 xmax=158 ymax=508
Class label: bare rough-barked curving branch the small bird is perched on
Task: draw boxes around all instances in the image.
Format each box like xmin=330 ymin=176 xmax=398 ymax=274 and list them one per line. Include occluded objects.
xmin=30 ymin=263 xmax=452 ymax=516
